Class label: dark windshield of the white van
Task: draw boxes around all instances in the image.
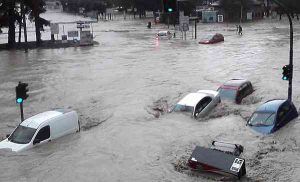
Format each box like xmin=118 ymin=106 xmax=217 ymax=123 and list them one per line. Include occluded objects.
xmin=8 ymin=125 xmax=36 ymax=144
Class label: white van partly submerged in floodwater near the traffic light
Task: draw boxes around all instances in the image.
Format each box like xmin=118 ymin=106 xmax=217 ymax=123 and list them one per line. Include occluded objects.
xmin=0 ymin=109 xmax=80 ymax=152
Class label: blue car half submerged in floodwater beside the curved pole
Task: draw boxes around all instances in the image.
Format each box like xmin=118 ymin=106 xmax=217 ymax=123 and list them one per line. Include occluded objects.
xmin=247 ymin=99 xmax=298 ymax=134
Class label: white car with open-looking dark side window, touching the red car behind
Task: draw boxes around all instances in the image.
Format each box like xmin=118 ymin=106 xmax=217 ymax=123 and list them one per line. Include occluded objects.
xmin=173 ymin=90 xmax=220 ymax=118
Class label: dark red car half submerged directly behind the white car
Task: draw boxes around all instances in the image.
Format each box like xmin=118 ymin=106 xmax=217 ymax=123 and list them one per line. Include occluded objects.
xmin=218 ymin=79 xmax=254 ymax=104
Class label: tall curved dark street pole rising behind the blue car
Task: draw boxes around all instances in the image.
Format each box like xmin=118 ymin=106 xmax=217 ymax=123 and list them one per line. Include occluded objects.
xmin=272 ymin=0 xmax=294 ymax=102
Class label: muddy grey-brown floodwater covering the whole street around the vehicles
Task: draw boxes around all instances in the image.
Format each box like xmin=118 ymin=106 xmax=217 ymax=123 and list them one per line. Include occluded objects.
xmin=0 ymin=13 xmax=300 ymax=182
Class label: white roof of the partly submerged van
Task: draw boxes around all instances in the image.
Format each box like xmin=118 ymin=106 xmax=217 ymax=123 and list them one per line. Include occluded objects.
xmin=21 ymin=111 xmax=64 ymax=129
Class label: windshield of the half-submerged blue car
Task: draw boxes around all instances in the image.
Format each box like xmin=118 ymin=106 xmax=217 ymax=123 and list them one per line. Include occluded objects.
xmin=248 ymin=112 xmax=276 ymax=126
